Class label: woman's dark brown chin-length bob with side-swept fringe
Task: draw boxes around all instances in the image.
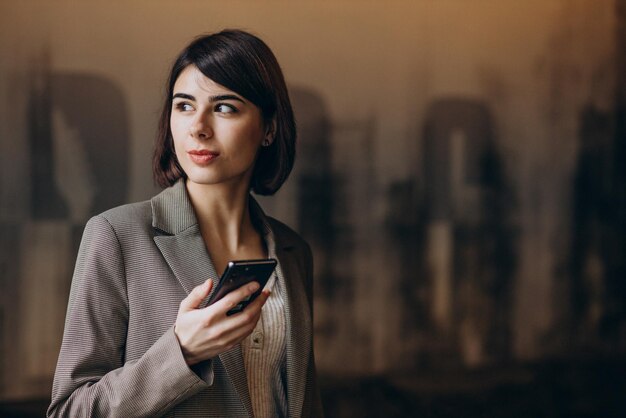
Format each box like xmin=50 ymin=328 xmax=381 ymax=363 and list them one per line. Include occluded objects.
xmin=152 ymin=29 xmax=296 ymax=195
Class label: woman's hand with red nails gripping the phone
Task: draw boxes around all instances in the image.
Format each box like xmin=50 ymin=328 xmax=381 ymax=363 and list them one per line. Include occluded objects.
xmin=174 ymin=280 xmax=270 ymax=366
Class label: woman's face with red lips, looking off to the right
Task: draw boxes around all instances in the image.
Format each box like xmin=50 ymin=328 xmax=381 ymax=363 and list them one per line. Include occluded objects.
xmin=170 ymin=65 xmax=265 ymax=186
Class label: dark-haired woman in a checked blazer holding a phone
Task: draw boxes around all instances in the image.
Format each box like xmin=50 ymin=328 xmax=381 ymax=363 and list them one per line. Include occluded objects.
xmin=48 ymin=30 xmax=321 ymax=417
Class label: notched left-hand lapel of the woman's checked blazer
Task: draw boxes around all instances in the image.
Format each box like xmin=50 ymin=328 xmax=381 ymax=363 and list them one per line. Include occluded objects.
xmin=151 ymin=180 xmax=253 ymax=416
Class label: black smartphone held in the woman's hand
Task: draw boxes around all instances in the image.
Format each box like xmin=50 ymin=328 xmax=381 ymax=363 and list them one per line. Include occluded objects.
xmin=209 ymin=258 xmax=276 ymax=315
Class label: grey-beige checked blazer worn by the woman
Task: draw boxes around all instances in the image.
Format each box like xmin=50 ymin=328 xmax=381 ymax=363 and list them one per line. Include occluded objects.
xmin=48 ymin=181 xmax=322 ymax=418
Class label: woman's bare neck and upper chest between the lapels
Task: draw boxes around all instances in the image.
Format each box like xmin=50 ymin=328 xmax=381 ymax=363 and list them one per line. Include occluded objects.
xmin=186 ymin=180 xmax=257 ymax=253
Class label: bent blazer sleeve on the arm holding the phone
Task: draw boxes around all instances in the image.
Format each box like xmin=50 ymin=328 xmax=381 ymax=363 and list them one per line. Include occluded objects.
xmin=47 ymin=216 xmax=208 ymax=417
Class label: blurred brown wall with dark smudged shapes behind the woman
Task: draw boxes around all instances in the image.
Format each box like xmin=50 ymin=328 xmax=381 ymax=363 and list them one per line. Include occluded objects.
xmin=0 ymin=0 xmax=626 ymax=416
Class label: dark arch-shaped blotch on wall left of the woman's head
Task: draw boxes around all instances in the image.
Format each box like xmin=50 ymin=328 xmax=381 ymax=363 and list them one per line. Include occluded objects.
xmin=28 ymin=61 xmax=131 ymax=219
